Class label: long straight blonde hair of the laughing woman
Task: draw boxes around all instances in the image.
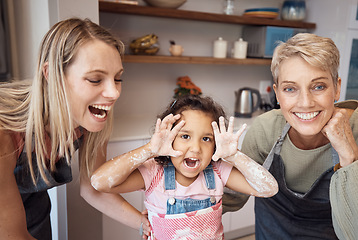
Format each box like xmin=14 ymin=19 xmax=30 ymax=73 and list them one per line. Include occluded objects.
xmin=0 ymin=18 xmax=124 ymax=183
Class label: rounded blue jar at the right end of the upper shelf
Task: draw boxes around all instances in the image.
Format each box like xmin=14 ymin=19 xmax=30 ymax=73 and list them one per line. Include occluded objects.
xmin=281 ymin=0 xmax=306 ymax=21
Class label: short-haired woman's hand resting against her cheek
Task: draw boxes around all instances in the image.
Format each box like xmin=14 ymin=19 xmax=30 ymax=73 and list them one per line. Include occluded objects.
xmin=322 ymin=109 xmax=358 ymax=167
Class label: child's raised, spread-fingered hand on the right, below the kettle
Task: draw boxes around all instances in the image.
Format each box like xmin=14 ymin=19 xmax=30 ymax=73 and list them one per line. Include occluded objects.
xmin=211 ymin=117 xmax=246 ymax=161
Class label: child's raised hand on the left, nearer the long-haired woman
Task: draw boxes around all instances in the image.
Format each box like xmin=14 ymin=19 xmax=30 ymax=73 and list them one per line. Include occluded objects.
xmin=150 ymin=114 xmax=185 ymax=157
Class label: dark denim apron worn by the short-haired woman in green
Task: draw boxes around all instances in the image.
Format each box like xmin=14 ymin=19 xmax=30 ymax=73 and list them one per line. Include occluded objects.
xmin=255 ymin=124 xmax=339 ymax=240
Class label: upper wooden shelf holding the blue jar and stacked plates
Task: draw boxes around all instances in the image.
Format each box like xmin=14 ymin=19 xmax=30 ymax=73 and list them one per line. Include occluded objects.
xmin=99 ymin=0 xmax=316 ymax=29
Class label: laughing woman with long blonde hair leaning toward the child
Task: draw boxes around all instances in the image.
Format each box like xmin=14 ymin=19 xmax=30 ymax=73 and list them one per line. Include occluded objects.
xmin=0 ymin=18 xmax=150 ymax=240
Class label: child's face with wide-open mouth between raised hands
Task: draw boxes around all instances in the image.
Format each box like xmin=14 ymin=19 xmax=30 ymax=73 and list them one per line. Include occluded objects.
xmin=171 ymin=110 xmax=215 ymax=186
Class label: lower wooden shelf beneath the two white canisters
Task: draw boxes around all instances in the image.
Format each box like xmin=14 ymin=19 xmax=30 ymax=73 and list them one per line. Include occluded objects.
xmin=124 ymin=55 xmax=271 ymax=65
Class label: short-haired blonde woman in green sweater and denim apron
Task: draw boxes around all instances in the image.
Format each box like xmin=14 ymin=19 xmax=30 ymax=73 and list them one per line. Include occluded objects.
xmin=224 ymin=33 xmax=358 ymax=240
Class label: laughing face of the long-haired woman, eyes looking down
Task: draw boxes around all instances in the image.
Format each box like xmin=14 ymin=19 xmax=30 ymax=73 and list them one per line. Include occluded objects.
xmin=65 ymin=40 xmax=123 ymax=132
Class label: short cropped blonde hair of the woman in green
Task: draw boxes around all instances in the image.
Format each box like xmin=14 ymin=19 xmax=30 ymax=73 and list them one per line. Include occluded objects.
xmin=271 ymin=33 xmax=339 ymax=87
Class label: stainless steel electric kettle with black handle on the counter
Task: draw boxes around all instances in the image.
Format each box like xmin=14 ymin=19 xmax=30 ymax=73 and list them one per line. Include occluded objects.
xmin=235 ymin=87 xmax=261 ymax=118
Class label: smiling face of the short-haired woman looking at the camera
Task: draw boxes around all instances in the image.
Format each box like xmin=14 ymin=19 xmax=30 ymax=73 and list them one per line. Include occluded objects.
xmin=274 ymin=56 xmax=341 ymax=140
